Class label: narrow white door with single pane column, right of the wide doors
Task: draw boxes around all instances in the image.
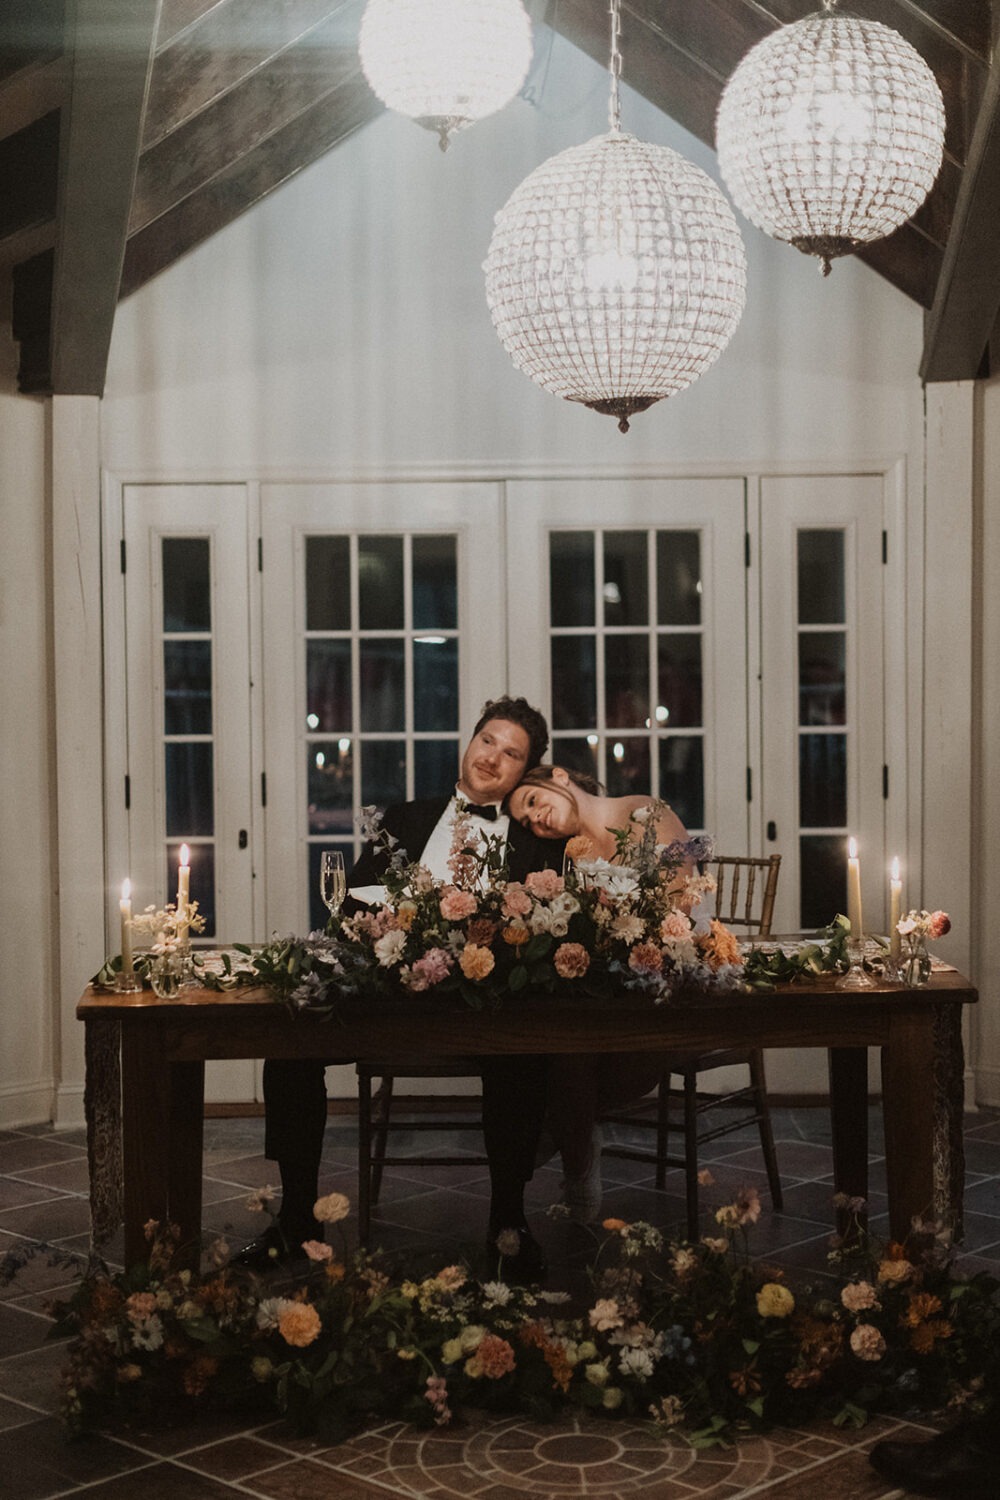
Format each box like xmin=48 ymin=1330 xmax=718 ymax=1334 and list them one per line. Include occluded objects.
xmin=759 ymin=474 xmax=901 ymax=932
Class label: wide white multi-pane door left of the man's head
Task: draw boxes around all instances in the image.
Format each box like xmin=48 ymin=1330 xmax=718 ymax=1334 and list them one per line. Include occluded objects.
xmin=261 ymin=483 xmax=507 ymax=932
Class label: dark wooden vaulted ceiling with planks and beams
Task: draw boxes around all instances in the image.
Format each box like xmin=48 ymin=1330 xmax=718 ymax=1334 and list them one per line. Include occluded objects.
xmin=0 ymin=0 xmax=1000 ymax=395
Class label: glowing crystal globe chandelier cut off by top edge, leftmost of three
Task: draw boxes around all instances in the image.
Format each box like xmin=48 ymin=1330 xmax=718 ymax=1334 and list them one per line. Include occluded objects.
xmin=358 ymin=0 xmax=531 ymax=152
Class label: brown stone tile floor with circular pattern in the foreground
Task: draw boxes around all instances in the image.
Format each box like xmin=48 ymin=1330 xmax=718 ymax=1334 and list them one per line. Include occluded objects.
xmin=0 ymin=1109 xmax=1000 ymax=1500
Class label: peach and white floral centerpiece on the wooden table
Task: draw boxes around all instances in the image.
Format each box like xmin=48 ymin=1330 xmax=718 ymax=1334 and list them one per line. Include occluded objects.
xmin=207 ymin=804 xmax=742 ymax=1013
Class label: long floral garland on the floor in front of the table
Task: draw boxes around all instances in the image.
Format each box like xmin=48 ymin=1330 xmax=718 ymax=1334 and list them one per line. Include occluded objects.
xmin=17 ymin=1175 xmax=1000 ymax=1446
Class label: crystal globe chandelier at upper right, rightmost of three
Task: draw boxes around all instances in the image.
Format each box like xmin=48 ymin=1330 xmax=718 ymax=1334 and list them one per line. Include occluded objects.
xmin=715 ymin=0 xmax=945 ymax=276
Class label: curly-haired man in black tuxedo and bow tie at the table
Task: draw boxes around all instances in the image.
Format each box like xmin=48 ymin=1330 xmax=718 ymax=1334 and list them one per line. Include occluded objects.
xmin=235 ymin=698 xmax=564 ymax=1277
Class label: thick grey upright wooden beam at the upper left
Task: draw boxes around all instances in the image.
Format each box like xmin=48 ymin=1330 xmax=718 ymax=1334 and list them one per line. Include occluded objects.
xmin=51 ymin=0 xmax=159 ymax=396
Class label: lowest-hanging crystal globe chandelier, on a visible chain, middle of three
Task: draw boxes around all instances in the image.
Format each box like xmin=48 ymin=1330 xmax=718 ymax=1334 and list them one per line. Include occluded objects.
xmin=483 ymin=0 xmax=747 ymax=432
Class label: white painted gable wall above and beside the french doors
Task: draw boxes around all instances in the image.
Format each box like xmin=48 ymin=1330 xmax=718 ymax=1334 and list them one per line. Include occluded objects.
xmin=0 ymin=41 xmax=983 ymax=1119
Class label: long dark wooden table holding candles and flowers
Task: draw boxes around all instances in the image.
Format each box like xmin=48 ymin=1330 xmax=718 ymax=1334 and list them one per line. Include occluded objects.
xmin=76 ymin=972 xmax=978 ymax=1265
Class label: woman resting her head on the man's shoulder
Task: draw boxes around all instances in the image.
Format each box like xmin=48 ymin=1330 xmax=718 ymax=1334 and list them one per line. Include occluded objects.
xmin=505 ymin=765 xmax=693 ymax=1224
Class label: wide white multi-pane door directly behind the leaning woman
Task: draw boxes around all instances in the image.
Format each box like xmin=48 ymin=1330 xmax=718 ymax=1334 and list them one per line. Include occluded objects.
xmin=507 ymin=479 xmax=750 ymax=854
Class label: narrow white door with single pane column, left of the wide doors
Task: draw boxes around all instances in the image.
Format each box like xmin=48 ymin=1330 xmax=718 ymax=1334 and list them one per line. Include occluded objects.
xmin=115 ymin=485 xmax=255 ymax=1100
